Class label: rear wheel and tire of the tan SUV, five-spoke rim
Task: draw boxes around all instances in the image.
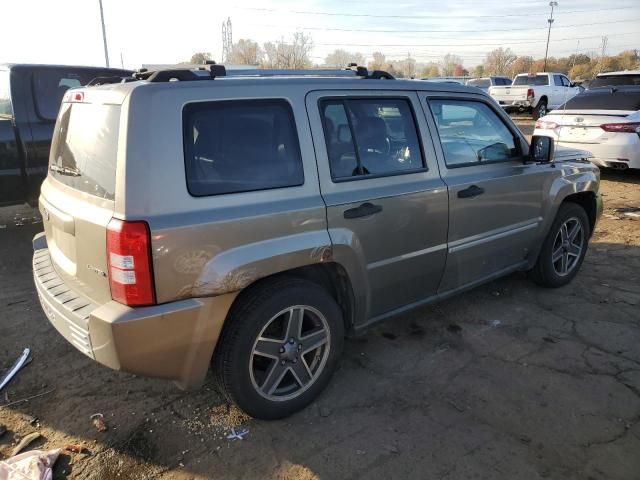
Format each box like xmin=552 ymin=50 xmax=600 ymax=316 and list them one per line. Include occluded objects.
xmin=214 ymin=277 xmax=344 ymax=420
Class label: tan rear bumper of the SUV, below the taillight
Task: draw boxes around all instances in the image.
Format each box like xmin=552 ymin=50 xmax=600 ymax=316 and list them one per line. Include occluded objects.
xmin=33 ymin=234 xmax=237 ymax=388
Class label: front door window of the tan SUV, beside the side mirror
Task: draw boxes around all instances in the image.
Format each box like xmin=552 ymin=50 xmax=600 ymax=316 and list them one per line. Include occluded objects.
xmin=429 ymin=100 xmax=520 ymax=167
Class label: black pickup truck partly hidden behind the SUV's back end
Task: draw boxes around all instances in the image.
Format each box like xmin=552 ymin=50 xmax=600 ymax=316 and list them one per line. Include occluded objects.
xmin=0 ymin=64 xmax=132 ymax=205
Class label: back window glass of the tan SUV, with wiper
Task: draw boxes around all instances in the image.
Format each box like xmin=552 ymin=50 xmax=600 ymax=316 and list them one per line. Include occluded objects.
xmin=49 ymin=103 xmax=120 ymax=200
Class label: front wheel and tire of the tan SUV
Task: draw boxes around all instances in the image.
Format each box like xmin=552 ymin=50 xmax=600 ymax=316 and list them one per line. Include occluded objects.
xmin=531 ymin=202 xmax=591 ymax=288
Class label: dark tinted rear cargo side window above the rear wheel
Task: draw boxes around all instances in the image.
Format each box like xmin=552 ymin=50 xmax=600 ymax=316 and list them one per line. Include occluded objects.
xmin=182 ymin=100 xmax=304 ymax=196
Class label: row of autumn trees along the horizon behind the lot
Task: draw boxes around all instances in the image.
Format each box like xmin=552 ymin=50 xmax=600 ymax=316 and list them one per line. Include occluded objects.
xmin=191 ymin=32 xmax=640 ymax=80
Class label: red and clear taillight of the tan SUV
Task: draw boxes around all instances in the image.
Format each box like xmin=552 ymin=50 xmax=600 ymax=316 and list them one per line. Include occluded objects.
xmin=107 ymin=218 xmax=155 ymax=306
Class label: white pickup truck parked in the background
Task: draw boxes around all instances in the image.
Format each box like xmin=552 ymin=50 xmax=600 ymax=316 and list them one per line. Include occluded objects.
xmin=489 ymin=72 xmax=581 ymax=120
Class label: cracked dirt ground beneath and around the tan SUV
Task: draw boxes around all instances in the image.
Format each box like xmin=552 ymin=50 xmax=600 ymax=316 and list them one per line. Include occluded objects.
xmin=0 ymin=117 xmax=640 ymax=480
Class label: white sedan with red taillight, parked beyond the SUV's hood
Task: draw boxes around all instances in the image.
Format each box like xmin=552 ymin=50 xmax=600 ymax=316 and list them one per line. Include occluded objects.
xmin=533 ymin=86 xmax=640 ymax=170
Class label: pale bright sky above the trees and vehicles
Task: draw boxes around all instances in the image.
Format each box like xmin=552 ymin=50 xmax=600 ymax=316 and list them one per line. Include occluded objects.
xmin=0 ymin=0 xmax=640 ymax=68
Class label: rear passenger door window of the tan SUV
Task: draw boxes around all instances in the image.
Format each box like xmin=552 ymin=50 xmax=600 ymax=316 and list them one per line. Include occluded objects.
xmin=320 ymin=98 xmax=424 ymax=179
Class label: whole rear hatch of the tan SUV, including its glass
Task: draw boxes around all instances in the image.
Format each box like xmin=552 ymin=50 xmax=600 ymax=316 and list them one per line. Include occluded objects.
xmin=40 ymin=90 xmax=121 ymax=303
